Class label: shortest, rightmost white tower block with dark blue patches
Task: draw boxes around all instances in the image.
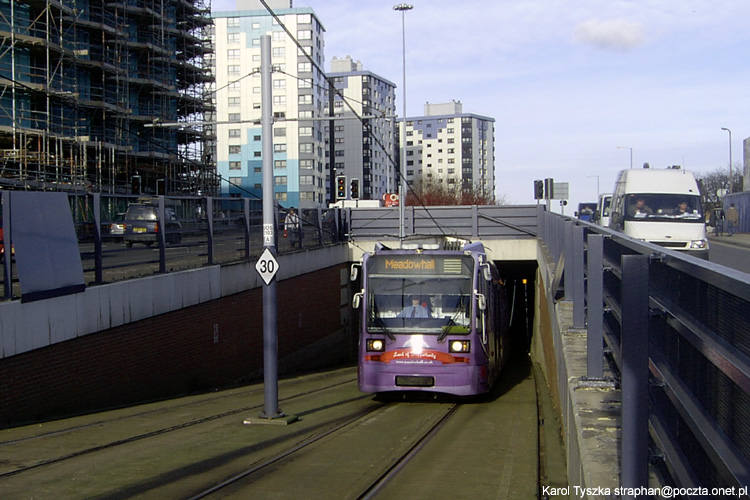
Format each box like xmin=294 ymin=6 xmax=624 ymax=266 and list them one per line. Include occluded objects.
xmin=399 ymin=101 xmax=495 ymax=197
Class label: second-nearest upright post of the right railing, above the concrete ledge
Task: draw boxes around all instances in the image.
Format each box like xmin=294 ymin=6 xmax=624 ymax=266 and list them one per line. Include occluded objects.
xmin=586 ymin=233 xmax=604 ymax=379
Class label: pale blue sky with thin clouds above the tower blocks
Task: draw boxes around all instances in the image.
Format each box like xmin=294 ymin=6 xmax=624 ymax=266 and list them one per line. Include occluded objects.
xmin=212 ymin=0 xmax=750 ymax=214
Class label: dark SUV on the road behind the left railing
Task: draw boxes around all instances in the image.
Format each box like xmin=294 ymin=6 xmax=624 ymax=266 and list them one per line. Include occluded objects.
xmin=123 ymin=203 xmax=182 ymax=248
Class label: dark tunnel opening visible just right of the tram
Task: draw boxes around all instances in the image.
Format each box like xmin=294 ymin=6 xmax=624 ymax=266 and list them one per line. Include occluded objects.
xmin=495 ymin=260 xmax=538 ymax=353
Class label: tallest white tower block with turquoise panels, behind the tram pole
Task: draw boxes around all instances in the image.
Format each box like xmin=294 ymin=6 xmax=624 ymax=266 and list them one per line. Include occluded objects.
xmin=214 ymin=0 xmax=326 ymax=208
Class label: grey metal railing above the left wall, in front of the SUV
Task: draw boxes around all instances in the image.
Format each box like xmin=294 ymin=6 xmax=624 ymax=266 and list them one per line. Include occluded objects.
xmin=0 ymin=192 xmax=345 ymax=300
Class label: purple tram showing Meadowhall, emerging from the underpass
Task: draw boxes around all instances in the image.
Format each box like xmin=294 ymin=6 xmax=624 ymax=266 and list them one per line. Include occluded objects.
xmin=354 ymin=243 xmax=509 ymax=396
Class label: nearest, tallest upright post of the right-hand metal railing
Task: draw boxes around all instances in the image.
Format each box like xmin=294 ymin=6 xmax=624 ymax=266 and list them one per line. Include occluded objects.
xmin=620 ymin=255 xmax=649 ymax=499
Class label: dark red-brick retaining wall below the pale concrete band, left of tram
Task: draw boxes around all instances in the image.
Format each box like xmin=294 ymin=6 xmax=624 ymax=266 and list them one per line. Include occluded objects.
xmin=0 ymin=266 xmax=355 ymax=426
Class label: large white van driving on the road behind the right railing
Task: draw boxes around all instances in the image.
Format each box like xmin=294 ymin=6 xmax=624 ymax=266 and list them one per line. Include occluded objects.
xmin=609 ymin=167 xmax=708 ymax=259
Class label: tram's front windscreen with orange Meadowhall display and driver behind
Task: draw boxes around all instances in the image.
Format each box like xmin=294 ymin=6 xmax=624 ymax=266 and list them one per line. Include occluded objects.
xmin=365 ymin=255 xmax=474 ymax=334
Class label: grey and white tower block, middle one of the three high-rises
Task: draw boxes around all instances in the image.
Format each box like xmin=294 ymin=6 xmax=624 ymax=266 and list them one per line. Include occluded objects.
xmin=324 ymin=56 xmax=398 ymax=200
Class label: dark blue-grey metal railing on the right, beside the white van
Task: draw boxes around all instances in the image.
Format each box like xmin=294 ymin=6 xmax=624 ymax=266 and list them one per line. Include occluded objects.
xmin=540 ymin=213 xmax=750 ymax=498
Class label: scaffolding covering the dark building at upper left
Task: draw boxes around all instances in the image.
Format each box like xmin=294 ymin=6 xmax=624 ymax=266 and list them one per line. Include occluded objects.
xmin=0 ymin=0 xmax=217 ymax=194
